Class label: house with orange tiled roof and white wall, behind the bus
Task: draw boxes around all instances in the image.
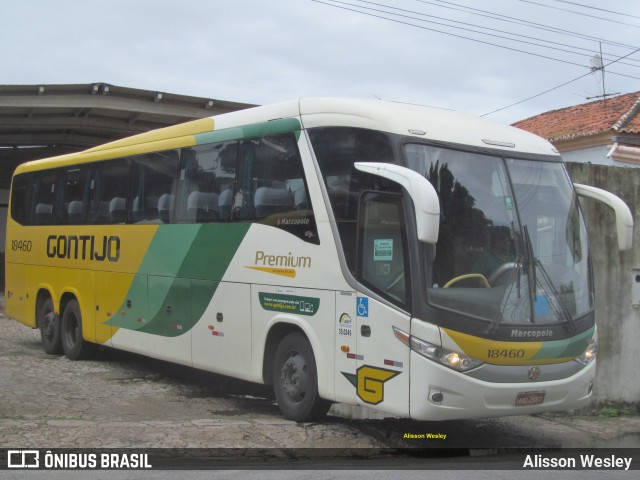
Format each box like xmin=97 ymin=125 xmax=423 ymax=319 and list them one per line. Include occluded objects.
xmin=514 ymin=92 xmax=640 ymax=167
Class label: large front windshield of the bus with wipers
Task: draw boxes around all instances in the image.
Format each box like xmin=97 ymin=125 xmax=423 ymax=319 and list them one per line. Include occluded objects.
xmin=405 ymin=144 xmax=593 ymax=327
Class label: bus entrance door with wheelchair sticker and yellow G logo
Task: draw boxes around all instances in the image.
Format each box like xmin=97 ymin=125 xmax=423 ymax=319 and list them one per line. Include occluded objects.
xmin=354 ymin=192 xmax=411 ymax=415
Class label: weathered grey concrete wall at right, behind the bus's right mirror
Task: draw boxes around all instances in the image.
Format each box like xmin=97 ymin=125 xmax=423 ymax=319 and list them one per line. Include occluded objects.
xmin=565 ymin=164 xmax=640 ymax=404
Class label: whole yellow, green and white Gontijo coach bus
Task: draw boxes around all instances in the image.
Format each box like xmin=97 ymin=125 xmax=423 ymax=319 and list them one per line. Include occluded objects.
xmin=5 ymin=98 xmax=633 ymax=421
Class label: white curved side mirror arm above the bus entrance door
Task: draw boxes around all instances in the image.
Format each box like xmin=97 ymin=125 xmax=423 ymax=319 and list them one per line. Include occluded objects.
xmin=354 ymin=162 xmax=440 ymax=244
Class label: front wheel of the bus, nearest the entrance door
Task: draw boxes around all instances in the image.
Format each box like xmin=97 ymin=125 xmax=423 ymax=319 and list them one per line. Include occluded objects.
xmin=273 ymin=332 xmax=331 ymax=422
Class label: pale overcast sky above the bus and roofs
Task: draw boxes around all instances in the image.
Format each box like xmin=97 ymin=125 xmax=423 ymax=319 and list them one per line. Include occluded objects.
xmin=0 ymin=0 xmax=640 ymax=123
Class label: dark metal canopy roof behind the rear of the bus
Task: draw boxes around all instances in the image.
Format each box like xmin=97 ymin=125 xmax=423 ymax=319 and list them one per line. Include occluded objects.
xmin=0 ymin=83 xmax=254 ymax=188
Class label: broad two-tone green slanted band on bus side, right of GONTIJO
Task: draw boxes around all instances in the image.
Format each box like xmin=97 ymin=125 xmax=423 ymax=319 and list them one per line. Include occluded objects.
xmin=106 ymin=223 xmax=250 ymax=337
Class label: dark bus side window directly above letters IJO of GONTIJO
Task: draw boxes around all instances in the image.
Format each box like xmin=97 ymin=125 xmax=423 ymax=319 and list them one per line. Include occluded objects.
xmin=88 ymin=159 xmax=131 ymax=225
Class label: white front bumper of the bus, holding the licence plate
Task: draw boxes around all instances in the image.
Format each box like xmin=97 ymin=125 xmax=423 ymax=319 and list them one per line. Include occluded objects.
xmin=409 ymin=352 xmax=596 ymax=420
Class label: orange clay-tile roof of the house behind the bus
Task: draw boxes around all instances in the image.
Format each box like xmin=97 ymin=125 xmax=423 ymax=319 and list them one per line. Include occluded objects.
xmin=513 ymin=92 xmax=640 ymax=142
